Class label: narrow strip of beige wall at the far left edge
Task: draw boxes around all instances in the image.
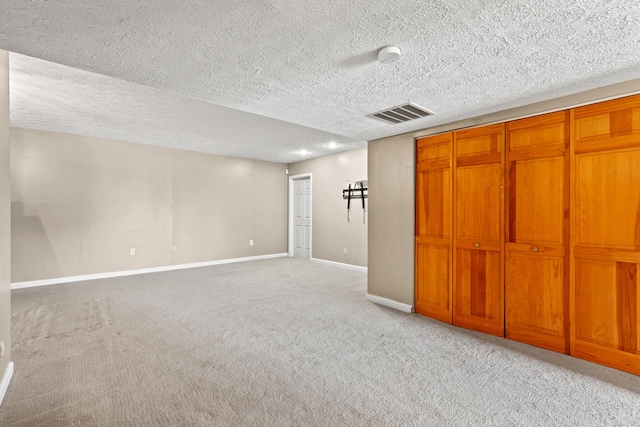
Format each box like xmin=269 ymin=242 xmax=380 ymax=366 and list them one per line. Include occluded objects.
xmin=0 ymin=50 xmax=11 ymax=381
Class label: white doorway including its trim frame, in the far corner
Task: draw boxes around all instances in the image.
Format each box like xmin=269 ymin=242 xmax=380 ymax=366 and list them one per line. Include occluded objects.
xmin=289 ymin=174 xmax=312 ymax=259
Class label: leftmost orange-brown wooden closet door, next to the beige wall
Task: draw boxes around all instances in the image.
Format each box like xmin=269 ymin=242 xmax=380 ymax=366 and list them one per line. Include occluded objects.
xmin=415 ymin=133 xmax=453 ymax=323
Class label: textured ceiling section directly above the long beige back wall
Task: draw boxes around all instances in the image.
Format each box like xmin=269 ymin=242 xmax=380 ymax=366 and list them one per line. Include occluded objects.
xmin=10 ymin=54 xmax=362 ymax=163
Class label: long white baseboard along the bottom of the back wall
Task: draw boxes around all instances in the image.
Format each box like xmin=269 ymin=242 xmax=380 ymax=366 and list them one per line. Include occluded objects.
xmin=11 ymin=253 xmax=288 ymax=289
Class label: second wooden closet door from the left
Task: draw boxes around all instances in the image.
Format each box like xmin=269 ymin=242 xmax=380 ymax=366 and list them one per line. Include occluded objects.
xmin=453 ymin=124 xmax=504 ymax=336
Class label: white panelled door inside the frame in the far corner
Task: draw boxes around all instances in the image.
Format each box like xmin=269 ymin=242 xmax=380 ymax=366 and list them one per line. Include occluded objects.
xmin=293 ymin=177 xmax=311 ymax=259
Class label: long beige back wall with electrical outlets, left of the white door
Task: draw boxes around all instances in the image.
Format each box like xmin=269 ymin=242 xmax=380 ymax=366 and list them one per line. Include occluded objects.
xmin=11 ymin=128 xmax=287 ymax=282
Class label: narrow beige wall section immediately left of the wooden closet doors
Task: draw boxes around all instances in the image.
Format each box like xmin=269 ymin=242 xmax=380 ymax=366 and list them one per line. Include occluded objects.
xmin=367 ymin=135 xmax=415 ymax=306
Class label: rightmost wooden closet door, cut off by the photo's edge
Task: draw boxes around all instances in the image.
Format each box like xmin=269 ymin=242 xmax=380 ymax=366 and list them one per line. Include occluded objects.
xmin=571 ymin=96 xmax=640 ymax=375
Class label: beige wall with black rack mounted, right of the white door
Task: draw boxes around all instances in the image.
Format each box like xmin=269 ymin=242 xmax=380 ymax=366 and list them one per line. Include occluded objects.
xmin=289 ymin=148 xmax=369 ymax=267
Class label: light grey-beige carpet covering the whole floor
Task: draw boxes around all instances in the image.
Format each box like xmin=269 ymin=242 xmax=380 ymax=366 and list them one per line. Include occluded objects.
xmin=0 ymin=258 xmax=640 ymax=426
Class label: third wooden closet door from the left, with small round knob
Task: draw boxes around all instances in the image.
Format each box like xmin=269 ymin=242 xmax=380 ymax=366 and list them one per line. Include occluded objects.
xmin=505 ymin=111 xmax=569 ymax=353
